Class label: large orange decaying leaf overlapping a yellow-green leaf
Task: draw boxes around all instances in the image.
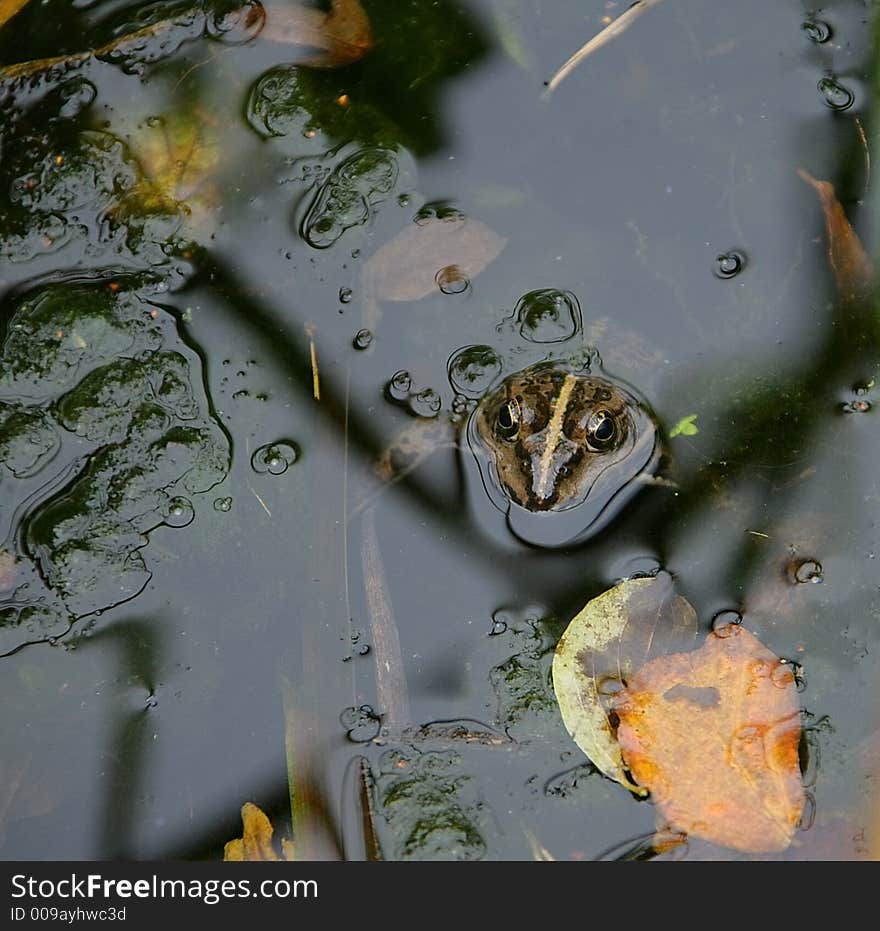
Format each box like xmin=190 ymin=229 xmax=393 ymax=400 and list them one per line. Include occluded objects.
xmin=614 ymin=625 xmax=804 ymax=852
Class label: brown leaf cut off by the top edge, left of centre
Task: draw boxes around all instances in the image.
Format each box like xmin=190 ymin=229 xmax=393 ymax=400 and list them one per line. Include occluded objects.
xmin=262 ymin=0 xmax=373 ymax=68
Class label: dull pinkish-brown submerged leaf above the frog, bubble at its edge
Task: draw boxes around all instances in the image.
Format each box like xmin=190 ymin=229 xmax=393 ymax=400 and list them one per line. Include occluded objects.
xmin=361 ymin=213 xmax=507 ymax=327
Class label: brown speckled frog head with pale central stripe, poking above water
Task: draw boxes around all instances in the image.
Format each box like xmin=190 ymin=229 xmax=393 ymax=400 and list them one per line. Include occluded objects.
xmin=467 ymin=360 xmax=661 ymax=546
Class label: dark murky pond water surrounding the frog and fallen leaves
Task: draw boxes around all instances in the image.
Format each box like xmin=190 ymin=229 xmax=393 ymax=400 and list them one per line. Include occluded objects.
xmin=0 ymin=0 xmax=880 ymax=859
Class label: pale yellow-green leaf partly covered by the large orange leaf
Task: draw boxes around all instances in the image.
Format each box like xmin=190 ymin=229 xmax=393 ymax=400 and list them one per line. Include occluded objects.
xmin=553 ymin=573 xmax=697 ymax=789
